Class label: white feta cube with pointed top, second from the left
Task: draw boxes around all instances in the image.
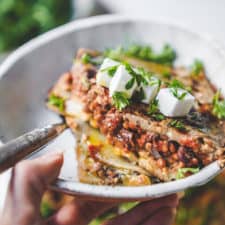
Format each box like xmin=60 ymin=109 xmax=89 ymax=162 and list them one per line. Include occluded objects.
xmin=109 ymin=65 xmax=137 ymax=98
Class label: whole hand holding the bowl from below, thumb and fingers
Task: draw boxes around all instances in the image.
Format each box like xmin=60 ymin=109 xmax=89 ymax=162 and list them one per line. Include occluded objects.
xmin=0 ymin=154 xmax=178 ymax=225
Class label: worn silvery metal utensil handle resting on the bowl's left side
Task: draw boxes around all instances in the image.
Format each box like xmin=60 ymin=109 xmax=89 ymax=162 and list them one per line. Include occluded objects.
xmin=0 ymin=123 xmax=66 ymax=173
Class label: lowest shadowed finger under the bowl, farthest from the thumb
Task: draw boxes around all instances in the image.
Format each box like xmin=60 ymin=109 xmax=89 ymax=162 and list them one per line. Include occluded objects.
xmin=142 ymin=208 xmax=175 ymax=225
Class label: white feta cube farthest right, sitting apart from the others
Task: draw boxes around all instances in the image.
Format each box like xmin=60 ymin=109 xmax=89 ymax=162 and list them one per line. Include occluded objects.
xmin=157 ymin=88 xmax=195 ymax=117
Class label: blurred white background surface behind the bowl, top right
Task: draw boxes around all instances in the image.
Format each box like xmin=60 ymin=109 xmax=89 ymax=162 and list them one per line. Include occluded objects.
xmin=96 ymin=0 xmax=225 ymax=44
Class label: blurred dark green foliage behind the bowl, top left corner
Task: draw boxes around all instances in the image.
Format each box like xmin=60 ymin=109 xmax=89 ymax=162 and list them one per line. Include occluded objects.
xmin=0 ymin=0 xmax=72 ymax=52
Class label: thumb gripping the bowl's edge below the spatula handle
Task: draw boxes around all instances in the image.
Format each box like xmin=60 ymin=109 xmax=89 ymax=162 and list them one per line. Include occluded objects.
xmin=6 ymin=153 xmax=63 ymax=219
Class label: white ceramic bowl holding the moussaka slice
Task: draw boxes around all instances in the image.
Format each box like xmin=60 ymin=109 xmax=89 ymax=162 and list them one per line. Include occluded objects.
xmin=0 ymin=16 xmax=225 ymax=200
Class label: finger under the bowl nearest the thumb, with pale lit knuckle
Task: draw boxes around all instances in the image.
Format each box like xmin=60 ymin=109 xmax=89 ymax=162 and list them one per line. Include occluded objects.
xmin=47 ymin=199 xmax=116 ymax=225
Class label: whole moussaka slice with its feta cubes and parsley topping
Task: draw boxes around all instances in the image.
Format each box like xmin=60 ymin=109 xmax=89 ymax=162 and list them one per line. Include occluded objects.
xmin=47 ymin=45 xmax=225 ymax=186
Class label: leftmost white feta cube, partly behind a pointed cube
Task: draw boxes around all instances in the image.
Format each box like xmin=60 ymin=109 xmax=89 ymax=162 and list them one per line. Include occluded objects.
xmin=96 ymin=58 xmax=120 ymax=88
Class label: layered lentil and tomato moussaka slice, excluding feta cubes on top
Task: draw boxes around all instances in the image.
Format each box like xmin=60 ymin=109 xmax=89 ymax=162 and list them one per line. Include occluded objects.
xmin=48 ymin=46 xmax=225 ymax=185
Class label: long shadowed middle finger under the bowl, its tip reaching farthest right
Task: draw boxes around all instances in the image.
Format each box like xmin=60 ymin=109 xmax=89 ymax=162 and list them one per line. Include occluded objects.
xmin=104 ymin=194 xmax=178 ymax=225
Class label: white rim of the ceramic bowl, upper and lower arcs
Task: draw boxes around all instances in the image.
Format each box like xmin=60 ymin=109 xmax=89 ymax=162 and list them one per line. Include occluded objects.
xmin=0 ymin=15 xmax=225 ymax=200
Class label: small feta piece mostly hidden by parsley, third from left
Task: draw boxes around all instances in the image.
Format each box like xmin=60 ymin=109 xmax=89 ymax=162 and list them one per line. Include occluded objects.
xmin=141 ymin=77 xmax=160 ymax=104
